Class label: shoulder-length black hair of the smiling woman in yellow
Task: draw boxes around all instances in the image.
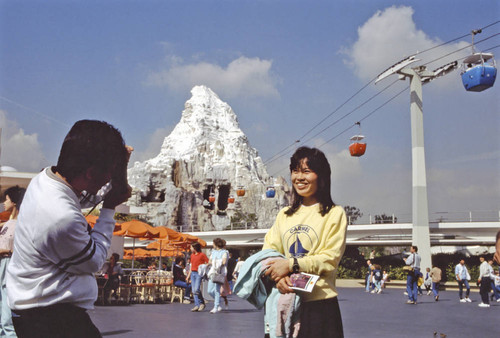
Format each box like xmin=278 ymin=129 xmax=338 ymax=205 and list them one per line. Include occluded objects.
xmin=285 ymin=147 xmax=335 ymax=216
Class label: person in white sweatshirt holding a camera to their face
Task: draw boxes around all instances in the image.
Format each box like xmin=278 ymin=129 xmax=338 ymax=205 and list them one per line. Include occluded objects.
xmin=7 ymin=120 xmax=132 ymax=338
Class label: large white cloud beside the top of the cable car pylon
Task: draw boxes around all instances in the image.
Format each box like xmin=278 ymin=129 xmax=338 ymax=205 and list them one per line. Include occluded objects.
xmin=341 ymin=6 xmax=470 ymax=80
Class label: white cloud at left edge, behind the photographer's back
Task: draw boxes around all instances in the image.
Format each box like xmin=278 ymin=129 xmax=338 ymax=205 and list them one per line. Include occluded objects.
xmin=0 ymin=110 xmax=48 ymax=172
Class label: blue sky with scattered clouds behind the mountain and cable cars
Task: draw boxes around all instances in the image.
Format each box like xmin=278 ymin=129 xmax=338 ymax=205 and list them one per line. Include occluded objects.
xmin=0 ymin=0 xmax=500 ymax=220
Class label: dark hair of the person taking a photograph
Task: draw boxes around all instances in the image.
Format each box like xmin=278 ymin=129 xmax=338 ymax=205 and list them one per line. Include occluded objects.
xmin=56 ymin=120 xmax=127 ymax=183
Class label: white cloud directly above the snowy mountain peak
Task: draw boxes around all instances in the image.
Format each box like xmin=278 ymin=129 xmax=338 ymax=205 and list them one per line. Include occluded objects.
xmin=146 ymin=56 xmax=279 ymax=99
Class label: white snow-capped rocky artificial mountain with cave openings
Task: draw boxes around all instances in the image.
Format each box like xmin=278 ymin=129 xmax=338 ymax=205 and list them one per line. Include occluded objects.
xmin=128 ymin=86 xmax=289 ymax=231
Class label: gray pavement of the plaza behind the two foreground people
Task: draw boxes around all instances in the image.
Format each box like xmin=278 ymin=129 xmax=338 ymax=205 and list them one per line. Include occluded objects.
xmin=89 ymin=287 xmax=500 ymax=338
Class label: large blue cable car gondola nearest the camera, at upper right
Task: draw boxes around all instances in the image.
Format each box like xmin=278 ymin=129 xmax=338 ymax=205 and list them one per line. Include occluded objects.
xmin=460 ymin=29 xmax=497 ymax=92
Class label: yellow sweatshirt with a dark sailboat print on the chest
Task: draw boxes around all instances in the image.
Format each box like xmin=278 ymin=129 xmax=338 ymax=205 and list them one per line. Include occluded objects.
xmin=263 ymin=204 xmax=347 ymax=302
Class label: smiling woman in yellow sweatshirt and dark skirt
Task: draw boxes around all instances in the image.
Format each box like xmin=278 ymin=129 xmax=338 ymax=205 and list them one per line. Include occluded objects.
xmin=263 ymin=147 xmax=347 ymax=338
